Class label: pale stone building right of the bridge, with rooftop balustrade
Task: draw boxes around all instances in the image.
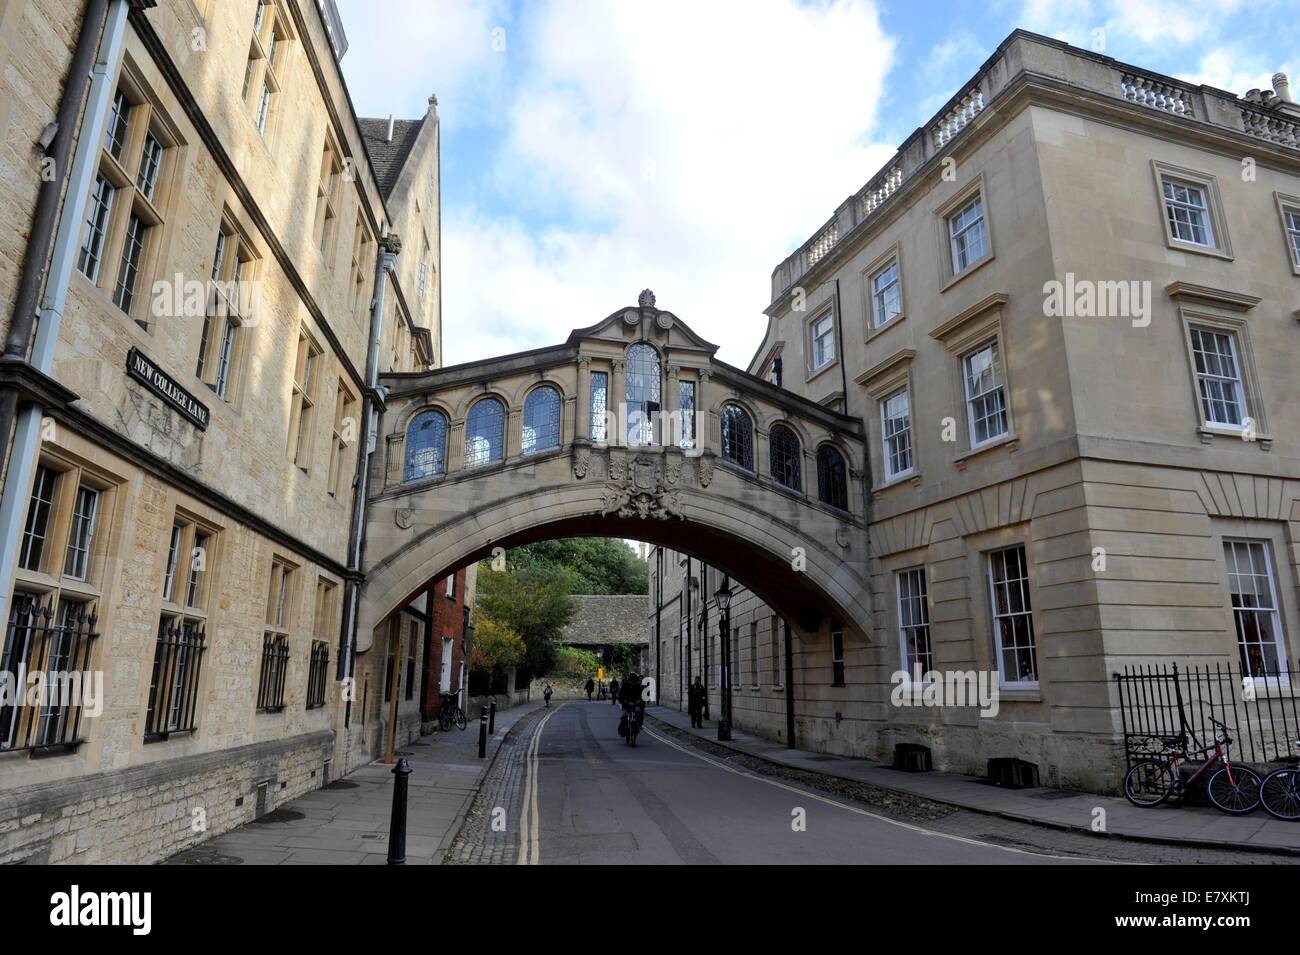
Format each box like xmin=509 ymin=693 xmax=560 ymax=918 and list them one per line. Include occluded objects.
xmin=650 ymin=31 xmax=1300 ymax=789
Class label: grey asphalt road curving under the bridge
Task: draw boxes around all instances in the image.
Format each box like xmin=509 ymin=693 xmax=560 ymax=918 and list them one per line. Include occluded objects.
xmin=516 ymin=702 xmax=1107 ymax=865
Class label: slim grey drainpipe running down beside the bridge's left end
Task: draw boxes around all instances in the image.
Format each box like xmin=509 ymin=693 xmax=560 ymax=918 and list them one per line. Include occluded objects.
xmin=335 ymin=233 xmax=402 ymax=706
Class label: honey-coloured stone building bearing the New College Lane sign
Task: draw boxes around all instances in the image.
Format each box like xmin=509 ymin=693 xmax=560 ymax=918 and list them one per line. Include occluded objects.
xmin=0 ymin=0 xmax=462 ymax=861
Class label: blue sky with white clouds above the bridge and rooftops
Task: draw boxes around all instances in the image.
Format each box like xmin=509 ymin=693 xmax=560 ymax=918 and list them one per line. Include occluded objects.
xmin=338 ymin=0 xmax=1300 ymax=366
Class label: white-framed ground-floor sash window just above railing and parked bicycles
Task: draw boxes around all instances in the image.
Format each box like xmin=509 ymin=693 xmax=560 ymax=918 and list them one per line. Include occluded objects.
xmin=1223 ymin=539 xmax=1287 ymax=677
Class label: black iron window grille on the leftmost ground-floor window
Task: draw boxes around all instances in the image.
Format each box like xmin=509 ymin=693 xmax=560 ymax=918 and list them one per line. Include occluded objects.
xmin=0 ymin=594 xmax=99 ymax=756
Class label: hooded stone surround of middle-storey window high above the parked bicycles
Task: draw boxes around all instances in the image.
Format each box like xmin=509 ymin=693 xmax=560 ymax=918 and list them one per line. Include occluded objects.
xmin=1166 ymin=282 xmax=1273 ymax=451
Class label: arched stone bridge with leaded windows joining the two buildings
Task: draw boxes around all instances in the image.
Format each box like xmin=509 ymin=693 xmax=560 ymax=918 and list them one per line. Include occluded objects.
xmin=358 ymin=291 xmax=870 ymax=650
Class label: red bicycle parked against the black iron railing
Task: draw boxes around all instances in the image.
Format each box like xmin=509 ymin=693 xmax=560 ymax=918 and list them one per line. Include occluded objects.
xmin=1125 ymin=717 xmax=1262 ymax=816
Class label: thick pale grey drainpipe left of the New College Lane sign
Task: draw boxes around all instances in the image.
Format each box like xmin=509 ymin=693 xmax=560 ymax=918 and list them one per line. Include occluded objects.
xmin=0 ymin=0 xmax=129 ymax=620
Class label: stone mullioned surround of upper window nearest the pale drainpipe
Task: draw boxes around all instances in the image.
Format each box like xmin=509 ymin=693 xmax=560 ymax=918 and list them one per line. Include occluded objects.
xmin=73 ymin=59 xmax=185 ymax=343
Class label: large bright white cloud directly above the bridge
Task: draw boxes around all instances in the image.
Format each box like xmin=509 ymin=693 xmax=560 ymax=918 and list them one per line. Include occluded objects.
xmin=431 ymin=0 xmax=893 ymax=365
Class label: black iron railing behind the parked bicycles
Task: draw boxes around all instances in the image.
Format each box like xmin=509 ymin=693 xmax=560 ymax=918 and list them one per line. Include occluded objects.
xmin=1114 ymin=660 xmax=1300 ymax=767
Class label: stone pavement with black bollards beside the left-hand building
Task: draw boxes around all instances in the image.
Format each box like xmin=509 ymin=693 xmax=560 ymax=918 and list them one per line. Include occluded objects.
xmin=166 ymin=703 xmax=541 ymax=865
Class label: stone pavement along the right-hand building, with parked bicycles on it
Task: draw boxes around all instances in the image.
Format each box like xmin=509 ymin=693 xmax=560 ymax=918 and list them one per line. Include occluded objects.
xmin=647 ymin=706 xmax=1300 ymax=855
